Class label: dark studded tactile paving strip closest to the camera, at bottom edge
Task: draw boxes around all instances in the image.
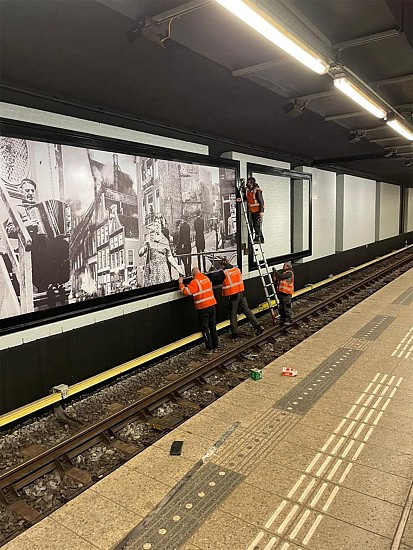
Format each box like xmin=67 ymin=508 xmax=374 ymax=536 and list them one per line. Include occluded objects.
xmin=116 ymin=464 xmax=244 ymax=550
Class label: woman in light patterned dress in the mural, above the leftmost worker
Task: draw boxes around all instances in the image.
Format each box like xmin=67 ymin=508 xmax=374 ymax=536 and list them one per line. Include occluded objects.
xmin=139 ymin=217 xmax=183 ymax=287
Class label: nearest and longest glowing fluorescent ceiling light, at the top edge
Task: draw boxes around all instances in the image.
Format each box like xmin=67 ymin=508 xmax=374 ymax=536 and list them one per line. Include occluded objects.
xmin=216 ymin=0 xmax=329 ymax=74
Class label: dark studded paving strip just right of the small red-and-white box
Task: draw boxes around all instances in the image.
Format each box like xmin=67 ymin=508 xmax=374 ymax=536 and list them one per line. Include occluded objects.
xmin=274 ymin=348 xmax=362 ymax=414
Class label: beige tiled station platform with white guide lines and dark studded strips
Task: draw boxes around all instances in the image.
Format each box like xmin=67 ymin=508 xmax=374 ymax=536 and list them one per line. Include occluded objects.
xmin=5 ymin=270 xmax=413 ymax=550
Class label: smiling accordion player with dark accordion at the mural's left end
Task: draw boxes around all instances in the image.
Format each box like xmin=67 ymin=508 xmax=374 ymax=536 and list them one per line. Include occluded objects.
xmin=5 ymin=178 xmax=70 ymax=292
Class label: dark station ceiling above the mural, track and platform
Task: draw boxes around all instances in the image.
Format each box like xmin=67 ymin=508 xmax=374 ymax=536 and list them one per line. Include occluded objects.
xmin=0 ymin=0 xmax=413 ymax=186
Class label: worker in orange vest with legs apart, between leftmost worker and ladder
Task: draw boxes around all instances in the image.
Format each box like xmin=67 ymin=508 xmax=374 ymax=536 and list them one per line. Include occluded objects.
xmin=208 ymin=258 xmax=264 ymax=338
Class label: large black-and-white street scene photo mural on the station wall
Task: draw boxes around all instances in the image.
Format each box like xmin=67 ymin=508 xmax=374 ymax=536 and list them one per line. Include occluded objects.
xmin=0 ymin=137 xmax=237 ymax=318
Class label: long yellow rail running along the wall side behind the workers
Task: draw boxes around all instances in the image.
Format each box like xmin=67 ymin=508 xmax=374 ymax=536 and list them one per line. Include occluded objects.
xmin=0 ymin=245 xmax=413 ymax=427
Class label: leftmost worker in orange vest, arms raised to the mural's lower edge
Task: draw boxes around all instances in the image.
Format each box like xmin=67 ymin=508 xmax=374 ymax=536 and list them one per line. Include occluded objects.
xmin=178 ymin=267 xmax=218 ymax=355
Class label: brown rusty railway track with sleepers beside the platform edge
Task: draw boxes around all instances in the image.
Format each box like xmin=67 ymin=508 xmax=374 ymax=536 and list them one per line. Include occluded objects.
xmin=0 ymin=253 xmax=413 ymax=544
